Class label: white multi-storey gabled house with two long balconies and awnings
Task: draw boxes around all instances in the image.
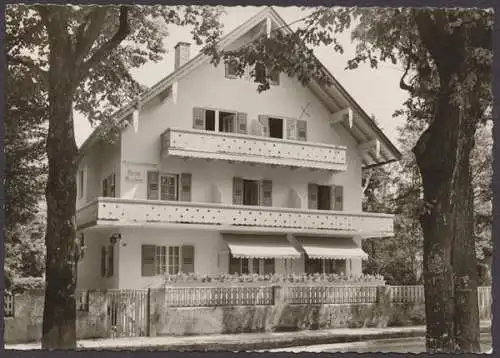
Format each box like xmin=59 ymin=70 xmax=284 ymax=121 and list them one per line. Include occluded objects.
xmin=77 ymin=7 xmax=400 ymax=288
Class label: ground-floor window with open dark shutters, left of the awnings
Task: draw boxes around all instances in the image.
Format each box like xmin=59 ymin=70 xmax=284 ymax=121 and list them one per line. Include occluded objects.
xmin=141 ymin=245 xmax=194 ymax=276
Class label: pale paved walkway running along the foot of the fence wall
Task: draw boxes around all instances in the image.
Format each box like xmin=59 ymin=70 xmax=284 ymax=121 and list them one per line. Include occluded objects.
xmin=5 ymin=321 xmax=491 ymax=351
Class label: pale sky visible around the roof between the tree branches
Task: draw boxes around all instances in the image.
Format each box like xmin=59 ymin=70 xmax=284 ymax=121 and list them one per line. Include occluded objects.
xmin=74 ymin=6 xmax=408 ymax=147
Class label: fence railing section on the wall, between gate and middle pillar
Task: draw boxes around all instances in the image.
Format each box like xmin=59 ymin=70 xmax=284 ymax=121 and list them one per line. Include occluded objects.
xmin=165 ymin=286 xmax=274 ymax=307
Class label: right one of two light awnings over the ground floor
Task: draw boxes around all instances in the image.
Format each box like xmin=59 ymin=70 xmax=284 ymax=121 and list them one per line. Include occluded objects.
xmin=296 ymin=236 xmax=368 ymax=260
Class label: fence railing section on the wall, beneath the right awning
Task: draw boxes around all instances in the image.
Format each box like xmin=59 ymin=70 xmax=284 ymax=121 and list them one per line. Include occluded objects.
xmin=283 ymin=286 xmax=377 ymax=305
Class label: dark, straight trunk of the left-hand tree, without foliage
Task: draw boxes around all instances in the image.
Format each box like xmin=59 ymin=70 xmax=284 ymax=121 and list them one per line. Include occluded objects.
xmin=42 ymin=48 xmax=77 ymax=349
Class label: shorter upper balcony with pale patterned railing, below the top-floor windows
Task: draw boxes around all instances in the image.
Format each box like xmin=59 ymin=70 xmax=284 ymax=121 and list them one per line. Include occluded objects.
xmin=161 ymin=128 xmax=347 ymax=171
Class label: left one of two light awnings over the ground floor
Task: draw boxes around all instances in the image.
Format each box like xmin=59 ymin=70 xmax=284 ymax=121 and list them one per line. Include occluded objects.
xmin=222 ymin=234 xmax=300 ymax=259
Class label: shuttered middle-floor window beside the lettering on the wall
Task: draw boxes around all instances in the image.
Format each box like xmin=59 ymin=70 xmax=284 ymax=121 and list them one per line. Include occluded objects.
xmin=147 ymin=171 xmax=191 ymax=201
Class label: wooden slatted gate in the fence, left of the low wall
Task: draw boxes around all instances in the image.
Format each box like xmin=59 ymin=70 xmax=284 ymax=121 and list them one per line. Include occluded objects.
xmin=107 ymin=290 xmax=149 ymax=338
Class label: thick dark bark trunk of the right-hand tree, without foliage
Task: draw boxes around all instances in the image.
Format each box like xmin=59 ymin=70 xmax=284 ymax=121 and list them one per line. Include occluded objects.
xmin=413 ymin=72 xmax=480 ymax=353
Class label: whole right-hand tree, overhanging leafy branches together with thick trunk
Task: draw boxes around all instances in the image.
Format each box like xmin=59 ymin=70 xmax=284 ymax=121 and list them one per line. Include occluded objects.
xmin=206 ymin=8 xmax=493 ymax=352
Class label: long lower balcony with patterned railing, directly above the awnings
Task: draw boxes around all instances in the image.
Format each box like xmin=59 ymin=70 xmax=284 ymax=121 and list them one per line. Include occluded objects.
xmin=77 ymin=198 xmax=394 ymax=237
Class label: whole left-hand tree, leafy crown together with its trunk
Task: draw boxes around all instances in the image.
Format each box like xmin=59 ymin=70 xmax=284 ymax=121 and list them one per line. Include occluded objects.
xmin=5 ymin=5 xmax=225 ymax=348
